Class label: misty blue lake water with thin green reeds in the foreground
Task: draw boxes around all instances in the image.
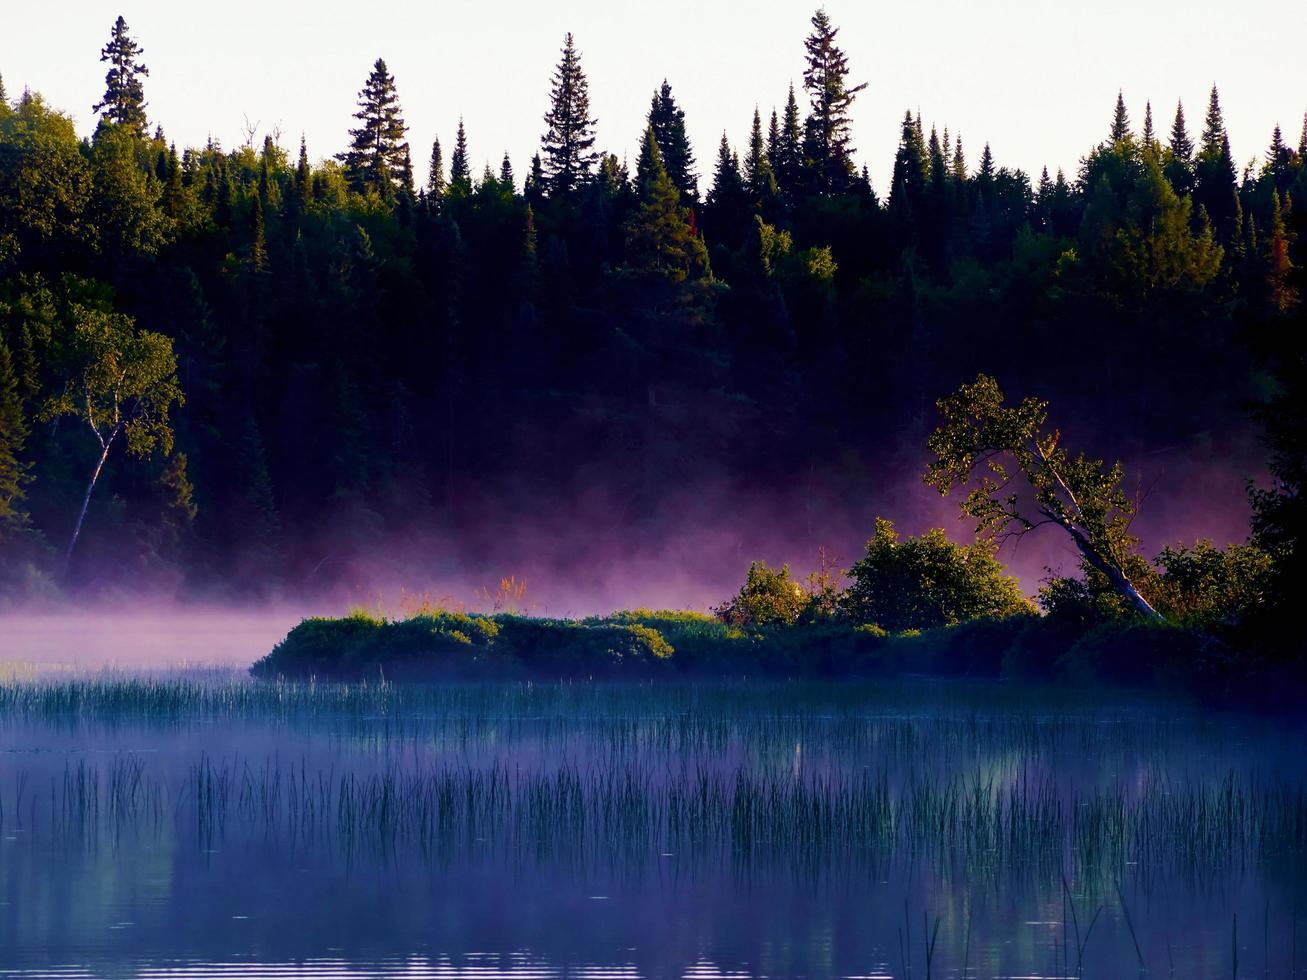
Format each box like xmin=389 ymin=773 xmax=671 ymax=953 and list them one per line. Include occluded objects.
xmin=0 ymin=670 xmax=1307 ymax=980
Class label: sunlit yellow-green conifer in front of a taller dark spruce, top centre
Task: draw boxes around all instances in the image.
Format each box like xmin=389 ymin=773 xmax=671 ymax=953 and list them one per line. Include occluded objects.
xmin=626 ymin=124 xmax=711 ymax=282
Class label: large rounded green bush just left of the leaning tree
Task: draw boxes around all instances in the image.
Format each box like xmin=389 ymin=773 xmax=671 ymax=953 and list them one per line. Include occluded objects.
xmin=839 ymin=517 xmax=1031 ymax=632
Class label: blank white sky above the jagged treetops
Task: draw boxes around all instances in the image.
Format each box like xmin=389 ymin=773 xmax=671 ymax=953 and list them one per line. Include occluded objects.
xmin=0 ymin=0 xmax=1307 ymax=192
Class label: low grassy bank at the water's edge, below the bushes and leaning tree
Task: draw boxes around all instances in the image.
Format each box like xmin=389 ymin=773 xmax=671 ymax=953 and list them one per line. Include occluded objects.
xmin=252 ymin=610 xmax=1275 ymax=694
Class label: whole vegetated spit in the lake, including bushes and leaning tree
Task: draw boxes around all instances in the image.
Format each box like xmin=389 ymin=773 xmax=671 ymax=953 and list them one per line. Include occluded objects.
xmin=251 ymin=375 xmax=1303 ymax=706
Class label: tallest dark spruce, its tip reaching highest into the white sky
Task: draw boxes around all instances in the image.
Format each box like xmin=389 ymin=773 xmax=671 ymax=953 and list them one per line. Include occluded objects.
xmin=804 ymin=9 xmax=867 ymax=193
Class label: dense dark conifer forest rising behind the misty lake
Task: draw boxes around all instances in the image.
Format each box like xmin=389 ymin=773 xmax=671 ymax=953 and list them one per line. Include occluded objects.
xmin=0 ymin=12 xmax=1307 ymax=637
